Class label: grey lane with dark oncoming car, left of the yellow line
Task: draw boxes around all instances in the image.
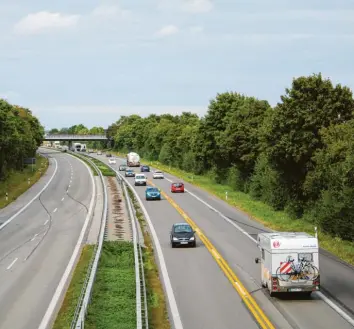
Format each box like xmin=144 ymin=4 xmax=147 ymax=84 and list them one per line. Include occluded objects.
xmin=130 ymin=179 xmax=258 ymax=329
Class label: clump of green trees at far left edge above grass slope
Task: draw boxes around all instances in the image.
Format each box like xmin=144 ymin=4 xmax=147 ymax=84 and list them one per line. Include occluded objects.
xmin=0 ymin=99 xmax=44 ymax=181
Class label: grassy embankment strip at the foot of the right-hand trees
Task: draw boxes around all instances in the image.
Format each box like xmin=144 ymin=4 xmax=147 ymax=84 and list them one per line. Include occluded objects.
xmin=108 ymin=152 xmax=354 ymax=265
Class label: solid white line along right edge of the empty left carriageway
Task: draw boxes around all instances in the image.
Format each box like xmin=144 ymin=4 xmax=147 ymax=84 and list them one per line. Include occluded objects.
xmin=38 ymin=154 xmax=96 ymax=329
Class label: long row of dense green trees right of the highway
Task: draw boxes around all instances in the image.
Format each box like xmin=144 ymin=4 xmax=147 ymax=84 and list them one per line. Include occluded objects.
xmin=107 ymin=74 xmax=354 ymax=240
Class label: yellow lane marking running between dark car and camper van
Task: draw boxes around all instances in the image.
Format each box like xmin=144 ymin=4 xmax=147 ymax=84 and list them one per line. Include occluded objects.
xmin=148 ymin=180 xmax=275 ymax=329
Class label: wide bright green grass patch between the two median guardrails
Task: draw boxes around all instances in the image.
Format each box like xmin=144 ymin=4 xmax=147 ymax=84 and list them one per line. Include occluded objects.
xmin=85 ymin=241 xmax=136 ymax=329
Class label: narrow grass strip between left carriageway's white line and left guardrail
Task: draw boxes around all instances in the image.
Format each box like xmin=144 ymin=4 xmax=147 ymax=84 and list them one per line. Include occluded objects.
xmin=53 ymin=245 xmax=95 ymax=329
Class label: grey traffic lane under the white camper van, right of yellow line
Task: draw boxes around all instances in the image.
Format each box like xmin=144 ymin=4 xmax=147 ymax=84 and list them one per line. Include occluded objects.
xmin=149 ymin=180 xmax=352 ymax=329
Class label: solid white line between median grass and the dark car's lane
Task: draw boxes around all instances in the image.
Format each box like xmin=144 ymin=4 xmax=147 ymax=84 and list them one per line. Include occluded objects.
xmin=115 ymin=167 xmax=183 ymax=329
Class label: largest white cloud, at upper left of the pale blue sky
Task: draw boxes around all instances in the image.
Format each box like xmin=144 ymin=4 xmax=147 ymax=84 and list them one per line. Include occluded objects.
xmin=15 ymin=11 xmax=80 ymax=34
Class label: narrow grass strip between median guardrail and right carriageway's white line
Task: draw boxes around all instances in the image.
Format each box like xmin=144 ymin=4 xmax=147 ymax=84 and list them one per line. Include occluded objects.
xmin=128 ymin=188 xmax=171 ymax=329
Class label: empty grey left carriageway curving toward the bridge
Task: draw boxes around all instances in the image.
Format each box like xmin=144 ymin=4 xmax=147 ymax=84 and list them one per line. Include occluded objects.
xmin=0 ymin=149 xmax=92 ymax=329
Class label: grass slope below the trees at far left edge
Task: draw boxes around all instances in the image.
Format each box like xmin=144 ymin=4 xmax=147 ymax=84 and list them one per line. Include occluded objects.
xmin=0 ymin=154 xmax=49 ymax=209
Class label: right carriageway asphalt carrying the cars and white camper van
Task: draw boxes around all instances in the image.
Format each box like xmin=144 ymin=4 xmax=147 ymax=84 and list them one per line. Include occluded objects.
xmin=94 ymin=155 xmax=354 ymax=329
